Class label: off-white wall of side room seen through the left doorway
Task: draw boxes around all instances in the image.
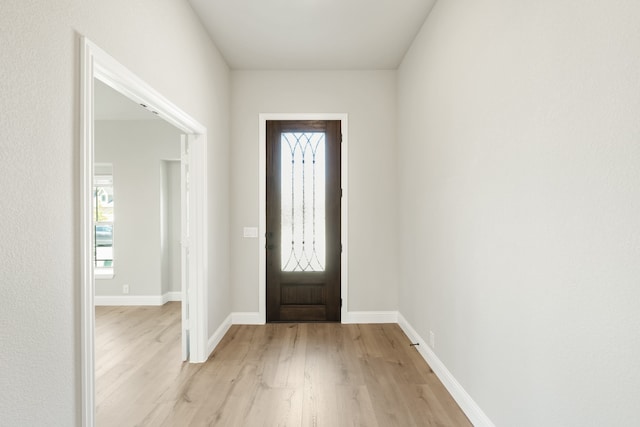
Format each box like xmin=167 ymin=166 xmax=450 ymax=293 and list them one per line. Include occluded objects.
xmin=94 ymin=120 xmax=181 ymax=296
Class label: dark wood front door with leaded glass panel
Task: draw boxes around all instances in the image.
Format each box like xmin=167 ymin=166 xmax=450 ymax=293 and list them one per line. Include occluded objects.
xmin=266 ymin=120 xmax=342 ymax=322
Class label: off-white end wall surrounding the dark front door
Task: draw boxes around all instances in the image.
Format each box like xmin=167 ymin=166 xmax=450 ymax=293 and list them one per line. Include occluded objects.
xmin=231 ymin=71 xmax=397 ymax=312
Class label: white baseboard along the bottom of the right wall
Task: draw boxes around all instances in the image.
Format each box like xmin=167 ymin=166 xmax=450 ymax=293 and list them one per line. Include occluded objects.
xmin=398 ymin=313 xmax=495 ymax=427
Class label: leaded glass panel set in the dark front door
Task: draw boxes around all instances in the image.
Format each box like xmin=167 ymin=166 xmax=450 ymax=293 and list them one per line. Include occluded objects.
xmin=280 ymin=132 xmax=326 ymax=271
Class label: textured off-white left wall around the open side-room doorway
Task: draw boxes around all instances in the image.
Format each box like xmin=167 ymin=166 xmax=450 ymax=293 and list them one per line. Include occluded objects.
xmin=0 ymin=0 xmax=230 ymax=427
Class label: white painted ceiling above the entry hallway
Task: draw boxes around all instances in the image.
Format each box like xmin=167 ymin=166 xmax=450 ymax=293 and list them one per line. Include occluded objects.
xmin=189 ymin=0 xmax=436 ymax=70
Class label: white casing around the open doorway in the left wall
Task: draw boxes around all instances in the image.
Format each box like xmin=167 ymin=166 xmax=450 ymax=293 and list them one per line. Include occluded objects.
xmin=79 ymin=37 xmax=208 ymax=427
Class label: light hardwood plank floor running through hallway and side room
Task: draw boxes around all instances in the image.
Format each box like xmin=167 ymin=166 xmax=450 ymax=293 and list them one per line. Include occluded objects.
xmin=96 ymin=303 xmax=471 ymax=427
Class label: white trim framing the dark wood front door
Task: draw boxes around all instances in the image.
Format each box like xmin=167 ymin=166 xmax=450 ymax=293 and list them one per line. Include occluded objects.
xmin=258 ymin=113 xmax=349 ymax=324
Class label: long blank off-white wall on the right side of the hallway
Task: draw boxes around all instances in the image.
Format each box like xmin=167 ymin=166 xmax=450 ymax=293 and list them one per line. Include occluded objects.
xmin=398 ymin=0 xmax=640 ymax=427
